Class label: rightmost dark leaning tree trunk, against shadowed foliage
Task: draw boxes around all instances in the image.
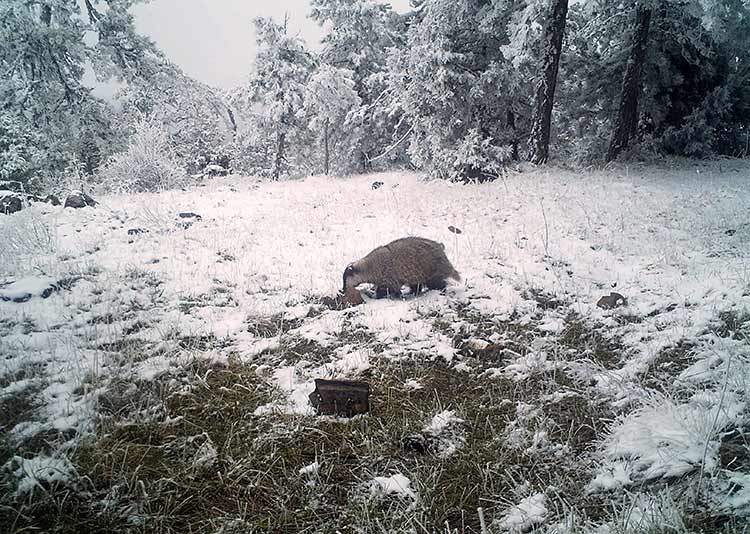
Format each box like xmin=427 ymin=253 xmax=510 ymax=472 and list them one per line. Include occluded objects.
xmin=607 ymin=6 xmax=651 ymax=161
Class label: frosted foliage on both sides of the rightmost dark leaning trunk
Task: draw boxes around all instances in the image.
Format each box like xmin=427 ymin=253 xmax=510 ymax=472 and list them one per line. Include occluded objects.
xmin=555 ymin=0 xmax=750 ymax=161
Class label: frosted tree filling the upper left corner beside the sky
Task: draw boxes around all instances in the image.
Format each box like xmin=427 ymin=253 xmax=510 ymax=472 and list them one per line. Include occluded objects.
xmin=0 ymin=0 xmax=166 ymax=189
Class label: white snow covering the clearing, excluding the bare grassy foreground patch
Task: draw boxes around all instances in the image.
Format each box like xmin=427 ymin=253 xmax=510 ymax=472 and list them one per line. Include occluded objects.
xmin=0 ymin=161 xmax=750 ymax=530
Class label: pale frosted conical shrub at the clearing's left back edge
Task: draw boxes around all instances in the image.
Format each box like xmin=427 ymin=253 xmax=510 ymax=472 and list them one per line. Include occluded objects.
xmin=99 ymin=118 xmax=187 ymax=193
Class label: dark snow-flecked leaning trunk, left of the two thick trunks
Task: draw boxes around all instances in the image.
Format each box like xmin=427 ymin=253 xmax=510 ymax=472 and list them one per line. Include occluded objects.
xmin=529 ymin=0 xmax=568 ymax=164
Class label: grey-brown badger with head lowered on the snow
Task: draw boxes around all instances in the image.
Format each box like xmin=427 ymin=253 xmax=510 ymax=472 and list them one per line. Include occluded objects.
xmin=342 ymin=237 xmax=461 ymax=298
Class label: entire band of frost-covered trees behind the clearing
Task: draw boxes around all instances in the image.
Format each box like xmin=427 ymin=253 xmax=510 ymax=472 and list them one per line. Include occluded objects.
xmin=0 ymin=0 xmax=750 ymax=193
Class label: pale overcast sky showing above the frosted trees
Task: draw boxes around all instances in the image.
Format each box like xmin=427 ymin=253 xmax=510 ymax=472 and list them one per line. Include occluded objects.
xmin=129 ymin=0 xmax=409 ymax=88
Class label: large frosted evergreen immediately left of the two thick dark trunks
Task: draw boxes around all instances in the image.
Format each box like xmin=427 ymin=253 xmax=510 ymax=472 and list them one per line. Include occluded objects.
xmin=390 ymin=0 xmax=516 ymax=178
